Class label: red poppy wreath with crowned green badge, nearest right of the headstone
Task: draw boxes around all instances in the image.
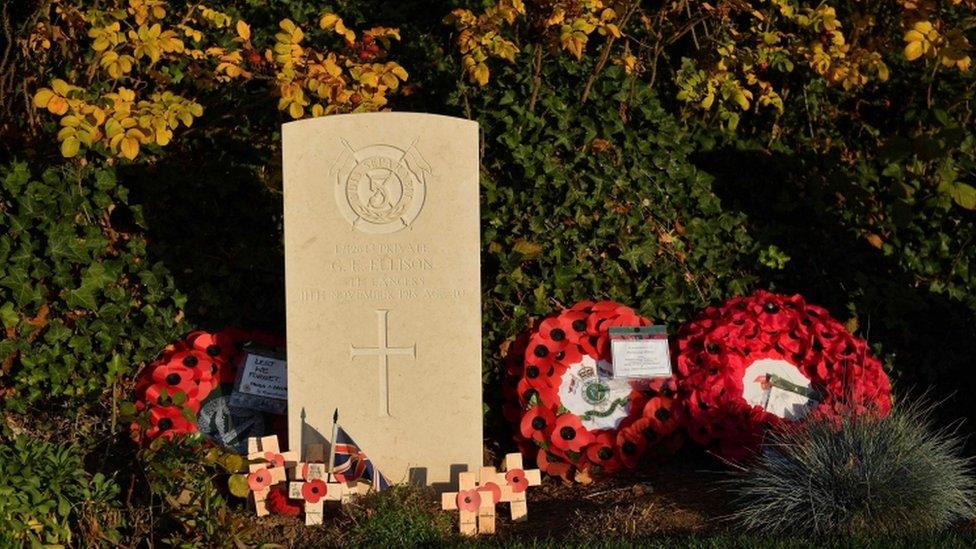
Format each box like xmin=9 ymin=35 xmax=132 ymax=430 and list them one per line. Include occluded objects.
xmin=503 ymin=301 xmax=682 ymax=479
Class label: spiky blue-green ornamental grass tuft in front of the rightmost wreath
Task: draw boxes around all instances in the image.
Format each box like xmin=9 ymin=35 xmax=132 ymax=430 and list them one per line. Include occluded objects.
xmin=730 ymin=402 xmax=976 ymax=538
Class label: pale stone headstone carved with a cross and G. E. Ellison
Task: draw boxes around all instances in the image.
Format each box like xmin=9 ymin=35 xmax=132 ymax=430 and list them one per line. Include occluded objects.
xmin=283 ymin=113 xmax=482 ymax=484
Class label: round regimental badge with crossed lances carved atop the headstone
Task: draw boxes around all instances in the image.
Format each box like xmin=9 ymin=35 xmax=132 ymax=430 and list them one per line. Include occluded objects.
xmin=329 ymin=139 xmax=430 ymax=234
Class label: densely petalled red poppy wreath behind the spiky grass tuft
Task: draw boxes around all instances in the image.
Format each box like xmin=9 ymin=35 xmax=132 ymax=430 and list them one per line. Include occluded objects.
xmin=675 ymin=291 xmax=891 ymax=460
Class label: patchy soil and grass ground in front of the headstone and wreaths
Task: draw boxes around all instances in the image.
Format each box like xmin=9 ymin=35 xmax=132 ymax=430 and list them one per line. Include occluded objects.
xmin=241 ymin=450 xmax=976 ymax=548
